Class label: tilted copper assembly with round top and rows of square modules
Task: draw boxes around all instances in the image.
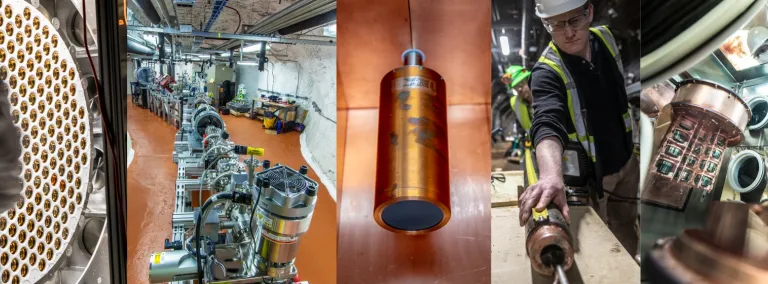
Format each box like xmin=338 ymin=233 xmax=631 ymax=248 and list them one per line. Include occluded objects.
xmin=641 ymin=79 xmax=751 ymax=209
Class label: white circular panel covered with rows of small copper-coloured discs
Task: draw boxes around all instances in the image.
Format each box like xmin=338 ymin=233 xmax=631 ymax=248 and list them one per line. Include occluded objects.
xmin=0 ymin=0 xmax=92 ymax=283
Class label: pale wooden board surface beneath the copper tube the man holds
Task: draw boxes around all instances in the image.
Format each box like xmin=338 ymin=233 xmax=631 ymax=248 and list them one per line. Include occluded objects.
xmin=491 ymin=206 xmax=640 ymax=284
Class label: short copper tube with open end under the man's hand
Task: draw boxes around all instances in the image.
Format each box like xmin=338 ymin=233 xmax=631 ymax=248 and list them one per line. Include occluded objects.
xmin=525 ymin=206 xmax=573 ymax=275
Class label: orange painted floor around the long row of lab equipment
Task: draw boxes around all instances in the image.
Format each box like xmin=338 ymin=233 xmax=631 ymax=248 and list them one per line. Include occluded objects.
xmin=127 ymin=101 xmax=337 ymax=284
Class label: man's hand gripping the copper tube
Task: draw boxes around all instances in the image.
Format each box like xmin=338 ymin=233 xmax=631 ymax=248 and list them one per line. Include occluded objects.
xmin=519 ymin=178 xmax=571 ymax=227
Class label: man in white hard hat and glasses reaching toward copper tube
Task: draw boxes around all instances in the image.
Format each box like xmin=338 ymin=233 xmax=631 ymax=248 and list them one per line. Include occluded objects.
xmin=520 ymin=0 xmax=639 ymax=256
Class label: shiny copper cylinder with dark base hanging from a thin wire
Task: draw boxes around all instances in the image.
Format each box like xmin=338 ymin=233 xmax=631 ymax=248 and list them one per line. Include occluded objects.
xmin=374 ymin=50 xmax=451 ymax=235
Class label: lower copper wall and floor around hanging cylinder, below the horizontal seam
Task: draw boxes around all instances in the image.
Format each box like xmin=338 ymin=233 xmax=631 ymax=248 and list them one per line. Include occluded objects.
xmin=338 ymin=106 xmax=491 ymax=284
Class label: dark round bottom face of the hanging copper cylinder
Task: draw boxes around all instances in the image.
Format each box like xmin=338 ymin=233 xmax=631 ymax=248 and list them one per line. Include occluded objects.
xmin=381 ymin=200 xmax=443 ymax=231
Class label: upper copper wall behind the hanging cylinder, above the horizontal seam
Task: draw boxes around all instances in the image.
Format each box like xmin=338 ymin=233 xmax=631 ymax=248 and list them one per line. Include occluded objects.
xmin=337 ymin=0 xmax=491 ymax=109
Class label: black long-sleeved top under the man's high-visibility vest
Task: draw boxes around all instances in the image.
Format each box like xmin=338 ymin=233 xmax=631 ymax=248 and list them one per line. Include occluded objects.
xmin=529 ymin=31 xmax=634 ymax=178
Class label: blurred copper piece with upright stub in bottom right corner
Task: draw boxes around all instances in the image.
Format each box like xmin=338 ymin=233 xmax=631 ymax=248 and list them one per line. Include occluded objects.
xmin=650 ymin=202 xmax=768 ymax=283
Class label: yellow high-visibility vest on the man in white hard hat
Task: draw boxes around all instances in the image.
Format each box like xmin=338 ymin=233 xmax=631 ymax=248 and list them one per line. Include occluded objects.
xmin=539 ymin=26 xmax=633 ymax=162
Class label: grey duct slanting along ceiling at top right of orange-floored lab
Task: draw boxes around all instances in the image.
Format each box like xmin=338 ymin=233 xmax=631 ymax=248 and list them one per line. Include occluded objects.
xmin=216 ymin=0 xmax=336 ymax=50
